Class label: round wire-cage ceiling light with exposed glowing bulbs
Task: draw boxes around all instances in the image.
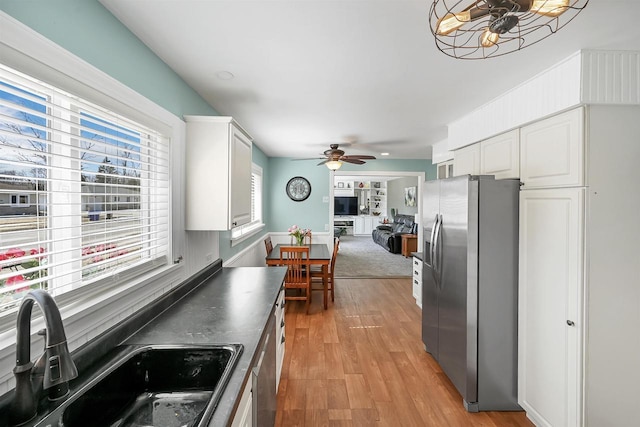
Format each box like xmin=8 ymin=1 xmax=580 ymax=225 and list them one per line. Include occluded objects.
xmin=429 ymin=0 xmax=589 ymax=59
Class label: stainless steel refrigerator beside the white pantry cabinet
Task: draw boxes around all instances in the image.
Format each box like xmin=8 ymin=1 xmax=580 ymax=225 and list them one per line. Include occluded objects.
xmin=422 ymin=175 xmax=521 ymax=412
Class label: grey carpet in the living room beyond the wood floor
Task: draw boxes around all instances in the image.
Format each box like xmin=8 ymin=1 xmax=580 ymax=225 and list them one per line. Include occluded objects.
xmin=333 ymin=236 xmax=413 ymax=278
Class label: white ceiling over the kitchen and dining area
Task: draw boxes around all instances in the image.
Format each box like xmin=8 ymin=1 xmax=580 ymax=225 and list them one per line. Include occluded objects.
xmin=100 ymin=0 xmax=640 ymax=158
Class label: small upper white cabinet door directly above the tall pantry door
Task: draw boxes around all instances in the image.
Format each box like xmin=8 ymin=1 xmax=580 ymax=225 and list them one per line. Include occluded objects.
xmin=520 ymin=108 xmax=585 ymax=189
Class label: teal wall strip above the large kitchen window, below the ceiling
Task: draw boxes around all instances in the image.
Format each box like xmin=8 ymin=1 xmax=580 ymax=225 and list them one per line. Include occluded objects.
xmin=0 ymin=0 xmax=218 ymax=117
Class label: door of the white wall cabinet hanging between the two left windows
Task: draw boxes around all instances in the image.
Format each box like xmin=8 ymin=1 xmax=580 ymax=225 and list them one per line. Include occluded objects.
xmin=229 ymin=126 xmax=251 ymax=228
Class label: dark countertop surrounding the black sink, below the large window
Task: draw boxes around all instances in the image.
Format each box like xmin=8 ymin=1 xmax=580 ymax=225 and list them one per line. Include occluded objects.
xmin=124 ymin=267 xmax=286 ymax=426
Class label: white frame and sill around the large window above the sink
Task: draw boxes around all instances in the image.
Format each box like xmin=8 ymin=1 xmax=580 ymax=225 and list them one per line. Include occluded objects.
xmin=0 ymin=12 xmax=187 ymax=348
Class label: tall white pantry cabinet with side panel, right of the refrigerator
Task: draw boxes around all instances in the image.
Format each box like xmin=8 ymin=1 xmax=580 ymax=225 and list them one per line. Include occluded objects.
xmin=518 ymin=105 xmax=640 ymax=427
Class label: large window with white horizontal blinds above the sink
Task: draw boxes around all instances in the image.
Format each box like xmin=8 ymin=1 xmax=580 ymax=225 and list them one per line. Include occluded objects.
xmin=0 ymin=66 xmax=170 ymax=310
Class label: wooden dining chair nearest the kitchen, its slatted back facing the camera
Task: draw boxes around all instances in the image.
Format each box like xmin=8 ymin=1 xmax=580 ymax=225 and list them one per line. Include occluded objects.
xmin=279 ymin=246 xmax=311 ymax=314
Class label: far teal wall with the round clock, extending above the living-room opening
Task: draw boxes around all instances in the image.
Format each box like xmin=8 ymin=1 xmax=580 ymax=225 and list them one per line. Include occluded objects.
xmin=267 ymin=157 xmax=436 ymax=232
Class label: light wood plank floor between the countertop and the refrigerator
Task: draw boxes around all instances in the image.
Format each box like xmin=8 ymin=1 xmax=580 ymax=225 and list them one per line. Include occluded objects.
xmin=276 ymin=278 xmax=533 ymax=427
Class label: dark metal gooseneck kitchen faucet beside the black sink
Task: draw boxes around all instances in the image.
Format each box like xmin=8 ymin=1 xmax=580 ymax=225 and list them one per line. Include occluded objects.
xmin=10 ymin=289 xmax=78 ymax=426
